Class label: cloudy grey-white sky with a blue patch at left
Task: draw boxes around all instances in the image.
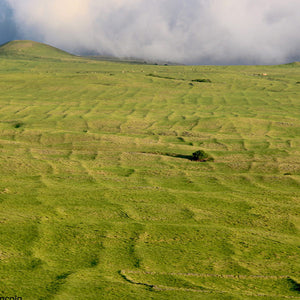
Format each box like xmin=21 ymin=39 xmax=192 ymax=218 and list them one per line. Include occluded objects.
xmin=0 ymin=0 xmax=300 ymax=65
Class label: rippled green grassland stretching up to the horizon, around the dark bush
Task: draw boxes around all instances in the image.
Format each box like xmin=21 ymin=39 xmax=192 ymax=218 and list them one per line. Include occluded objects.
xmin=0 ymin=42 xmax=300 ymax=300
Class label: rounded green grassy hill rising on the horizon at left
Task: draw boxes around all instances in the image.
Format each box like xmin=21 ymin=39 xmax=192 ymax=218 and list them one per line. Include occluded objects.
xmin=0 ymin=40 xmax=75 ymax=59
